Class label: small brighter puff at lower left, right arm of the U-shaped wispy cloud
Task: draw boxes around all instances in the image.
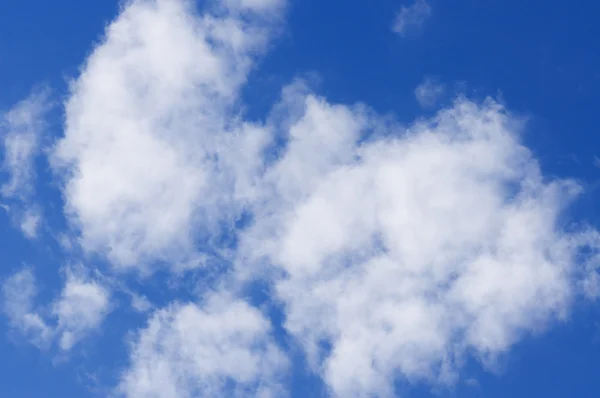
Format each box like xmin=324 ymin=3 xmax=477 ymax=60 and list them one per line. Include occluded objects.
xmin=52 ymin=272 xmax=110 ymax=351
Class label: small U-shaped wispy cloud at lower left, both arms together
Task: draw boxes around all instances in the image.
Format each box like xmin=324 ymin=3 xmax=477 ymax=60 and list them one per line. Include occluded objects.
xmin=2 ymin=268 xmax=110 ymax=352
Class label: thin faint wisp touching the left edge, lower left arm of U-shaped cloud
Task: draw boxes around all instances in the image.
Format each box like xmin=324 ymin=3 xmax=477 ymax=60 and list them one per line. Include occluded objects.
xmin=2 ymin=268 xmax=52 ymax=347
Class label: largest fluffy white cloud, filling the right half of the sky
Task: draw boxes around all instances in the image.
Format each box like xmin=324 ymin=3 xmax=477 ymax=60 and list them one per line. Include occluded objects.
xmin=240 ymin=91 xmax=596 ymax=397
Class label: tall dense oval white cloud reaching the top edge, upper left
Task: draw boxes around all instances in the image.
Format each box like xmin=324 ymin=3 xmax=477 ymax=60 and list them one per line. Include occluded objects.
xmin=53 ymin=0 xmax=281 ymax=269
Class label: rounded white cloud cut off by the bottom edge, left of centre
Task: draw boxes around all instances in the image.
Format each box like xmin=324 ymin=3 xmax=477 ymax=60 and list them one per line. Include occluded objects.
xmin=119 ymin=294 xmax=287 ymax=398
